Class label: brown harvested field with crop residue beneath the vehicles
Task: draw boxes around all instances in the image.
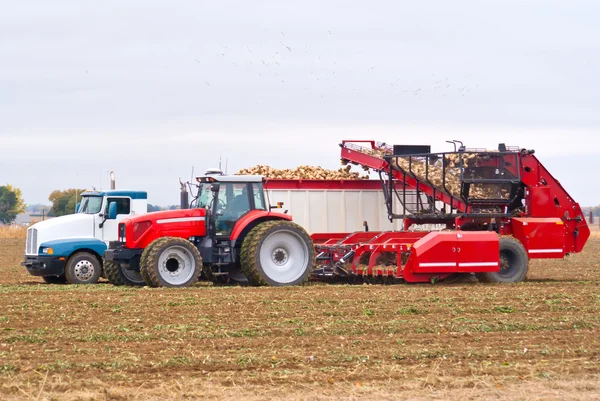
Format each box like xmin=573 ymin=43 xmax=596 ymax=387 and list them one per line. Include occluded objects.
xmin=0 ymin=227 xmax=600 ymax=400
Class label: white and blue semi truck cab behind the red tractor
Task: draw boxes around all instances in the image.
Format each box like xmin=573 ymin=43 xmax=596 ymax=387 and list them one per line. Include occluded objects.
xmin=22 ymin=190 xmax=148 ymax=284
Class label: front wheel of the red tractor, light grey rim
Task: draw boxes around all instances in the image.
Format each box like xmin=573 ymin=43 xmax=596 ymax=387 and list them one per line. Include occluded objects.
xmin=140 ymin=237 xmax=202 ymax=287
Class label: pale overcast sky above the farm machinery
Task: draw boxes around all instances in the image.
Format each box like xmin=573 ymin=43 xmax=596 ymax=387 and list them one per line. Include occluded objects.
xmin=0 ymin=0 xmax=600 ymax=205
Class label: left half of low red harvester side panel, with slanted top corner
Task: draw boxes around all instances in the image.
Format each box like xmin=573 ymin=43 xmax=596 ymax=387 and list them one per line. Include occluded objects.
xmin=411 ymin=231 xmax=458 ymax=274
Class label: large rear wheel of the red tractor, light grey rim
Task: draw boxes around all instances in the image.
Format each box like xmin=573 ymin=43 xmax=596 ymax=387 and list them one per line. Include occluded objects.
xmin=240 ymin=221 xmax=315 ymax=286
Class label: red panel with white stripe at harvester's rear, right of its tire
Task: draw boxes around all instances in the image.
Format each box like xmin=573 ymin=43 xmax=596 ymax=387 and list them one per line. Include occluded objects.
xmin=512 ymin=218 xmax=565 ymax=259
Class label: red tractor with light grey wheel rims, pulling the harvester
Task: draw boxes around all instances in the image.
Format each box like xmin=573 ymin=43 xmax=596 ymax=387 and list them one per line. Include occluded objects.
xmin=104 ymin=174 xmax=315 ymax=287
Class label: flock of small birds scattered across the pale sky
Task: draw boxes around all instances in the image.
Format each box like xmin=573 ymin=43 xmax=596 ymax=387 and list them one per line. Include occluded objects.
xmin=193 ymin=30 xmax=479 ymax=100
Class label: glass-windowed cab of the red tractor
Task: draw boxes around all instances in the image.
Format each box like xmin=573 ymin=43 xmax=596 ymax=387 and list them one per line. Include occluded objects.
xmin=196 ymin=172 xmax=267 ymax=238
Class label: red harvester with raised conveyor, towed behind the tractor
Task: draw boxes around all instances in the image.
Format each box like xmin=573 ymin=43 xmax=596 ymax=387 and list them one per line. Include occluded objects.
xmin=313 ymin=140 xmax=590 ymax=282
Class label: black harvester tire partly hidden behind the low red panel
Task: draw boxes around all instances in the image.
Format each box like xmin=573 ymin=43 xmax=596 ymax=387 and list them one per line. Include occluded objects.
xmin=475 ymin=236 xmax=529 ymax=283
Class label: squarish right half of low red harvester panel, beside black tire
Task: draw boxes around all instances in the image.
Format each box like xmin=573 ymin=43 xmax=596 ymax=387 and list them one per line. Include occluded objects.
xmin=457 ymin=231 xmax=500 ymax=273
